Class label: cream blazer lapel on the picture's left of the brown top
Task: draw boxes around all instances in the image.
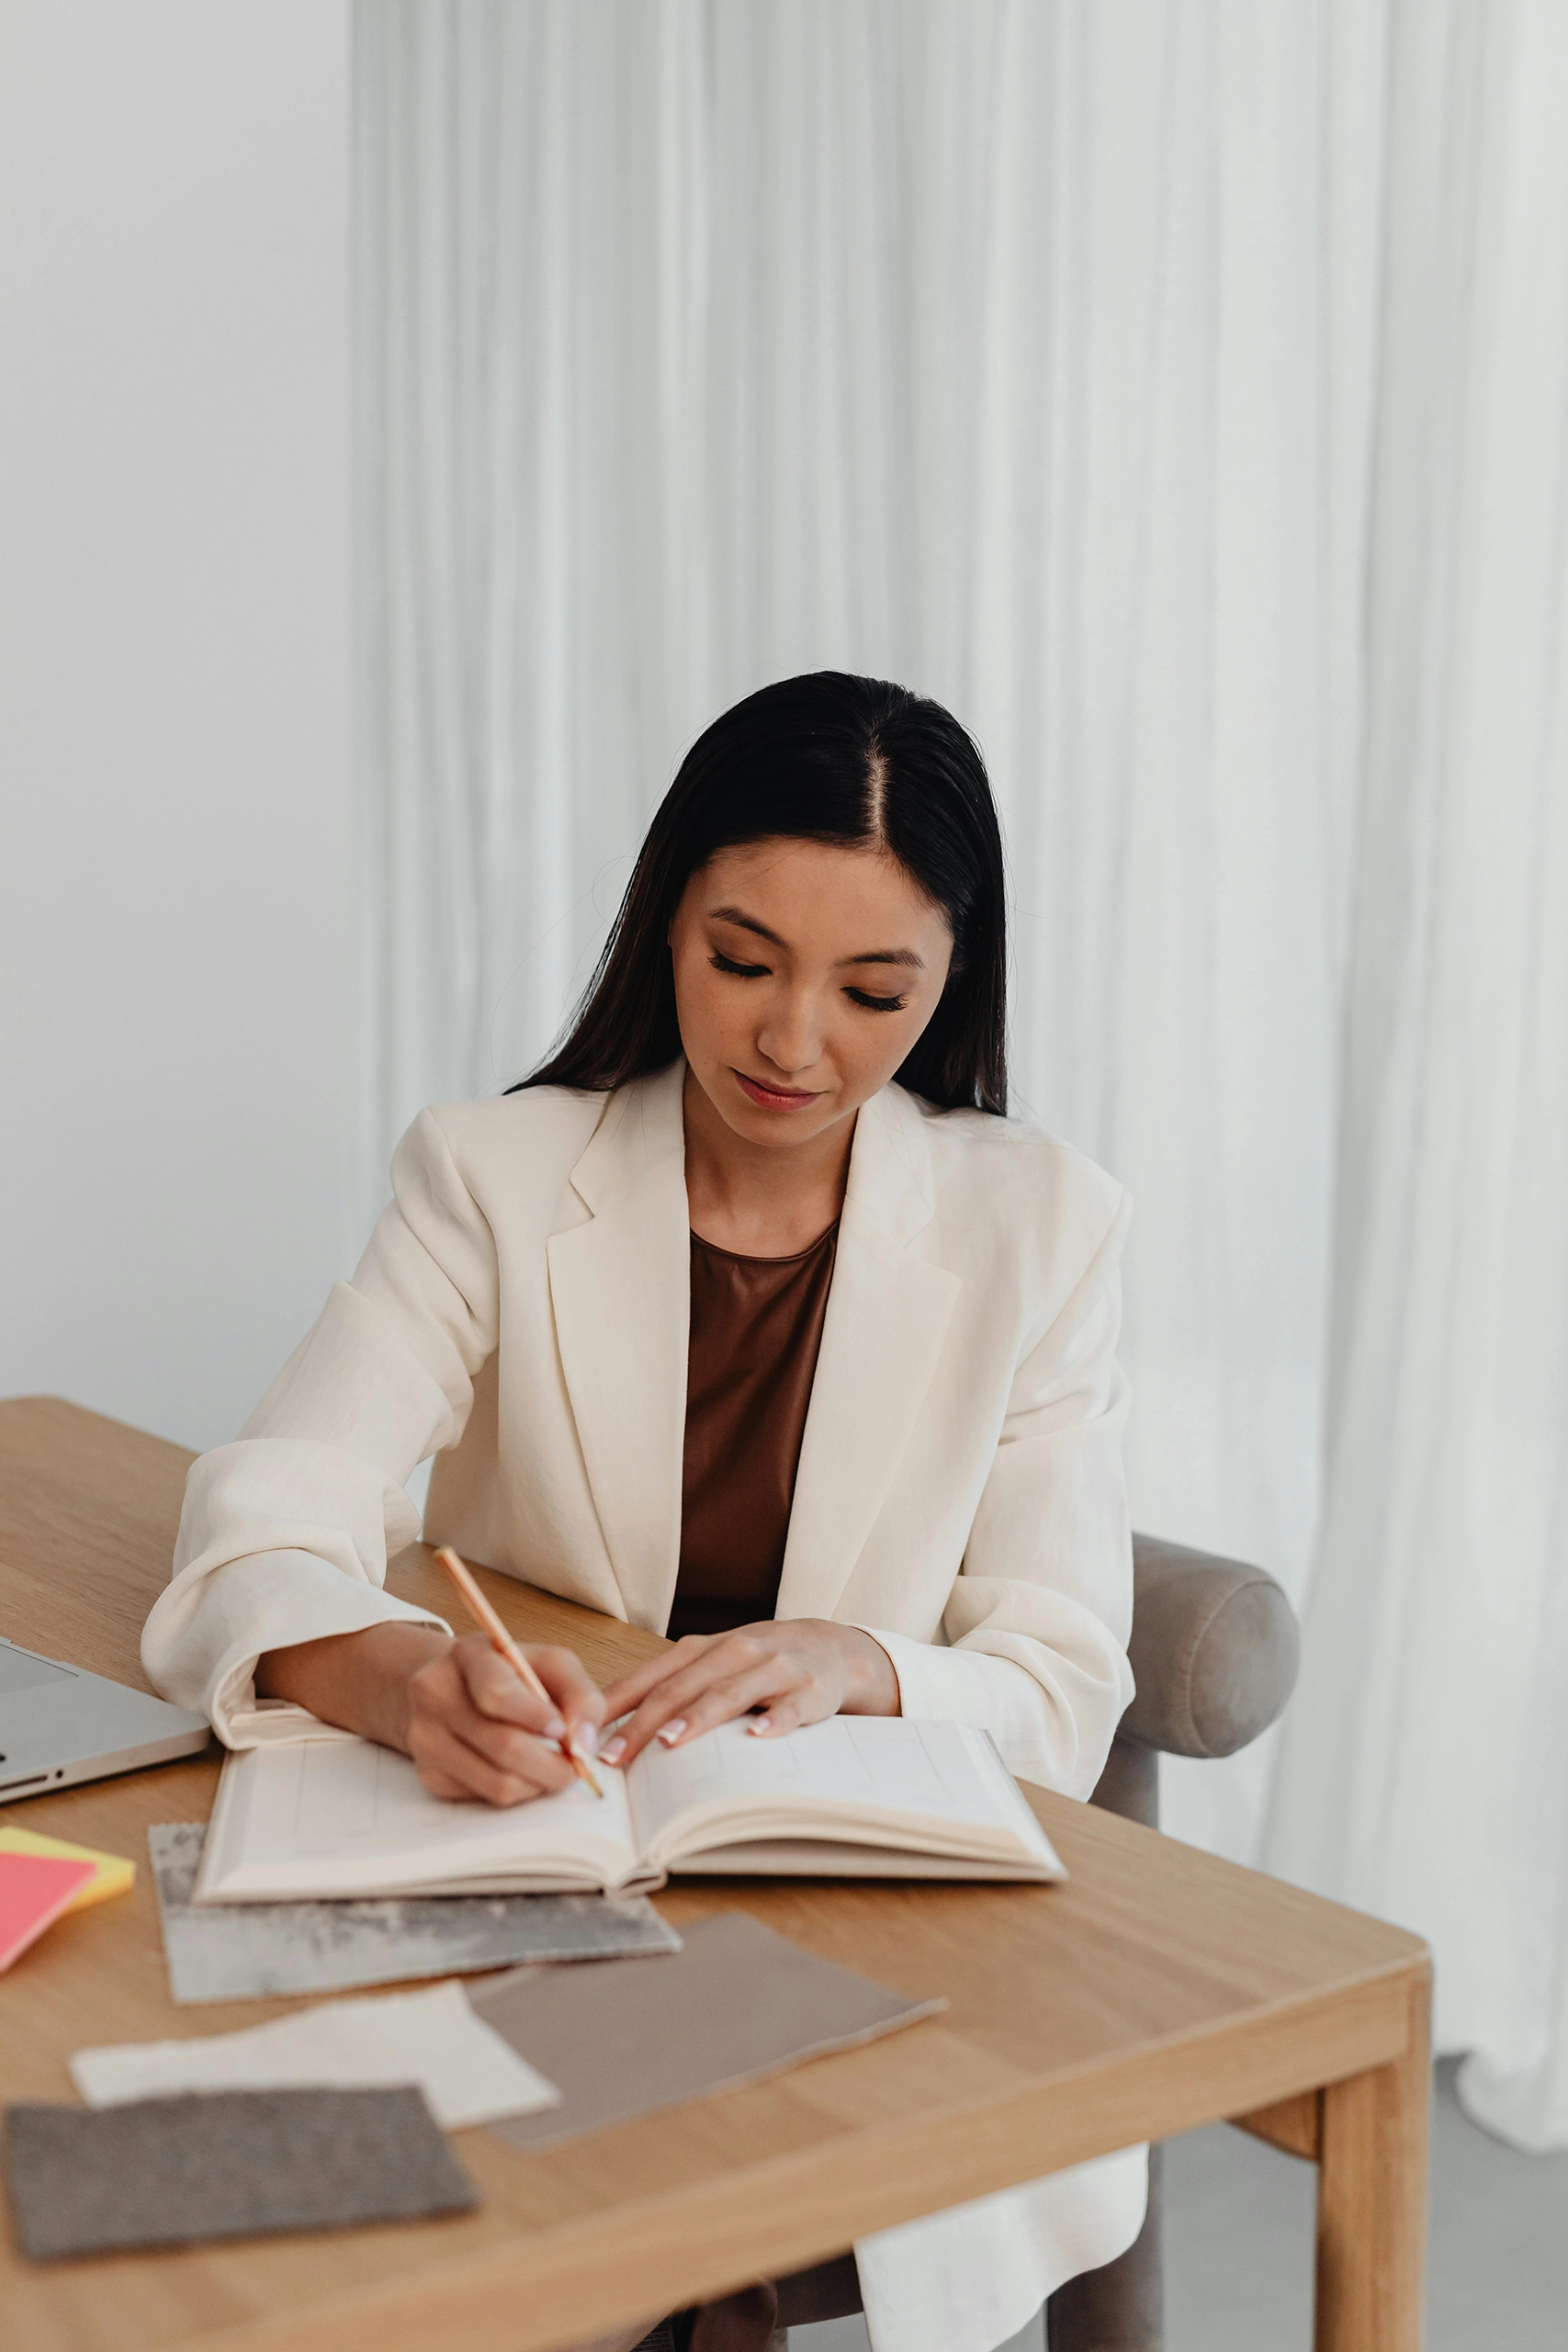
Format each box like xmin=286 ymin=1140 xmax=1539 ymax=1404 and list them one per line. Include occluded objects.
xmin=547 ymin=1061 xmax=691 ymax=1633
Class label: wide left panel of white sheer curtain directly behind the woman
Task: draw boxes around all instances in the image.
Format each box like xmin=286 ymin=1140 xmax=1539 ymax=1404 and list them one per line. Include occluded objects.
xmin=357 ymin=0 xmax=1378 ymax=1853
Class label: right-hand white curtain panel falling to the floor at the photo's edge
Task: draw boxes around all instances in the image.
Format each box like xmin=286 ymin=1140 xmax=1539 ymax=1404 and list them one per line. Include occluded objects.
xmin=1267 ymin=0 xmax=1568 ymax=2145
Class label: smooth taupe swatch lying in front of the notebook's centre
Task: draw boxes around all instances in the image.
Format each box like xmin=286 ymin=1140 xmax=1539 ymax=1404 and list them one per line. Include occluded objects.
xmin=479 ymin=1912 xmax=947 ymax=2147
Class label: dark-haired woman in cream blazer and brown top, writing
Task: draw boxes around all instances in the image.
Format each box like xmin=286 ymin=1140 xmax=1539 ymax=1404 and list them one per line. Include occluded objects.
xmin=143 ymin=673 xmax=1143 ymax=2352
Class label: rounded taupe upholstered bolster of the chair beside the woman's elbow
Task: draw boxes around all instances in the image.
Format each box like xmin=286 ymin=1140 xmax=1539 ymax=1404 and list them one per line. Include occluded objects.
xmin=1119 ymin=1536 xmax=1300 ymax=1757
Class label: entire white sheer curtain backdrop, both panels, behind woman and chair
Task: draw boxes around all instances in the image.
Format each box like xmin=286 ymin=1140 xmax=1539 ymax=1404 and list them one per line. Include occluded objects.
xmin=357 ymin=0 xmax=1568 ymax=2143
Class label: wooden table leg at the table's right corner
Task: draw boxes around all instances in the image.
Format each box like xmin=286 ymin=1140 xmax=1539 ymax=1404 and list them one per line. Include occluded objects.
xmin=1314 ymin=1971 xmax=1432 ymax=2352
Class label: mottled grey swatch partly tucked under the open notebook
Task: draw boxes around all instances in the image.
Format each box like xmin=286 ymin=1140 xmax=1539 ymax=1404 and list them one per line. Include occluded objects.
xmin=148 ymin=1820 xmax=680 ymax=2004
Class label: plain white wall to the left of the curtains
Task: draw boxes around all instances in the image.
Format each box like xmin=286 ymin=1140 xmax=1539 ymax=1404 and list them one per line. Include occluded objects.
xmin=0 ymin=0 xmax=355 ymax=1444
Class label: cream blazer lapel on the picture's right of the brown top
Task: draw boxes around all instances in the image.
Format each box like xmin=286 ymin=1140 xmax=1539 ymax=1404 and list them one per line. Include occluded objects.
xmin=778 ymin=1087 xmax=964 ymax=1618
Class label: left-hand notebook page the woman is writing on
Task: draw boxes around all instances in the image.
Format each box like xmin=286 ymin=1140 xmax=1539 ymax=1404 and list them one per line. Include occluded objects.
xmin=195 ymin=1740 xmax=632 ymax=1903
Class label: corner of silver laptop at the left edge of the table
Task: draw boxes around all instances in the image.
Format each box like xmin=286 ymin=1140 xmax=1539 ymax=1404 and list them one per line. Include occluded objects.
xmin=0 ymin=1637 xmax=211 ymax=1804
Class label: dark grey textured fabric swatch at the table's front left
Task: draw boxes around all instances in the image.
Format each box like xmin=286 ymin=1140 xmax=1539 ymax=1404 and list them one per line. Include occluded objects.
xmin=5 ymin=2088 xmax=479 ymax=2260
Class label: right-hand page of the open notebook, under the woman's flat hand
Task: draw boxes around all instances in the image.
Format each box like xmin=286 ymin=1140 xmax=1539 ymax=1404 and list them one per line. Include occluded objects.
xmin=630 ymin=1714 xmax=1032 ymax=1853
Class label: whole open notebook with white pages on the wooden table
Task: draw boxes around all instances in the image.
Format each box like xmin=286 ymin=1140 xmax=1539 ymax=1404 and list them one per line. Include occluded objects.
xmin=193 ymin=1714 xmax=1065 ymax=1903
